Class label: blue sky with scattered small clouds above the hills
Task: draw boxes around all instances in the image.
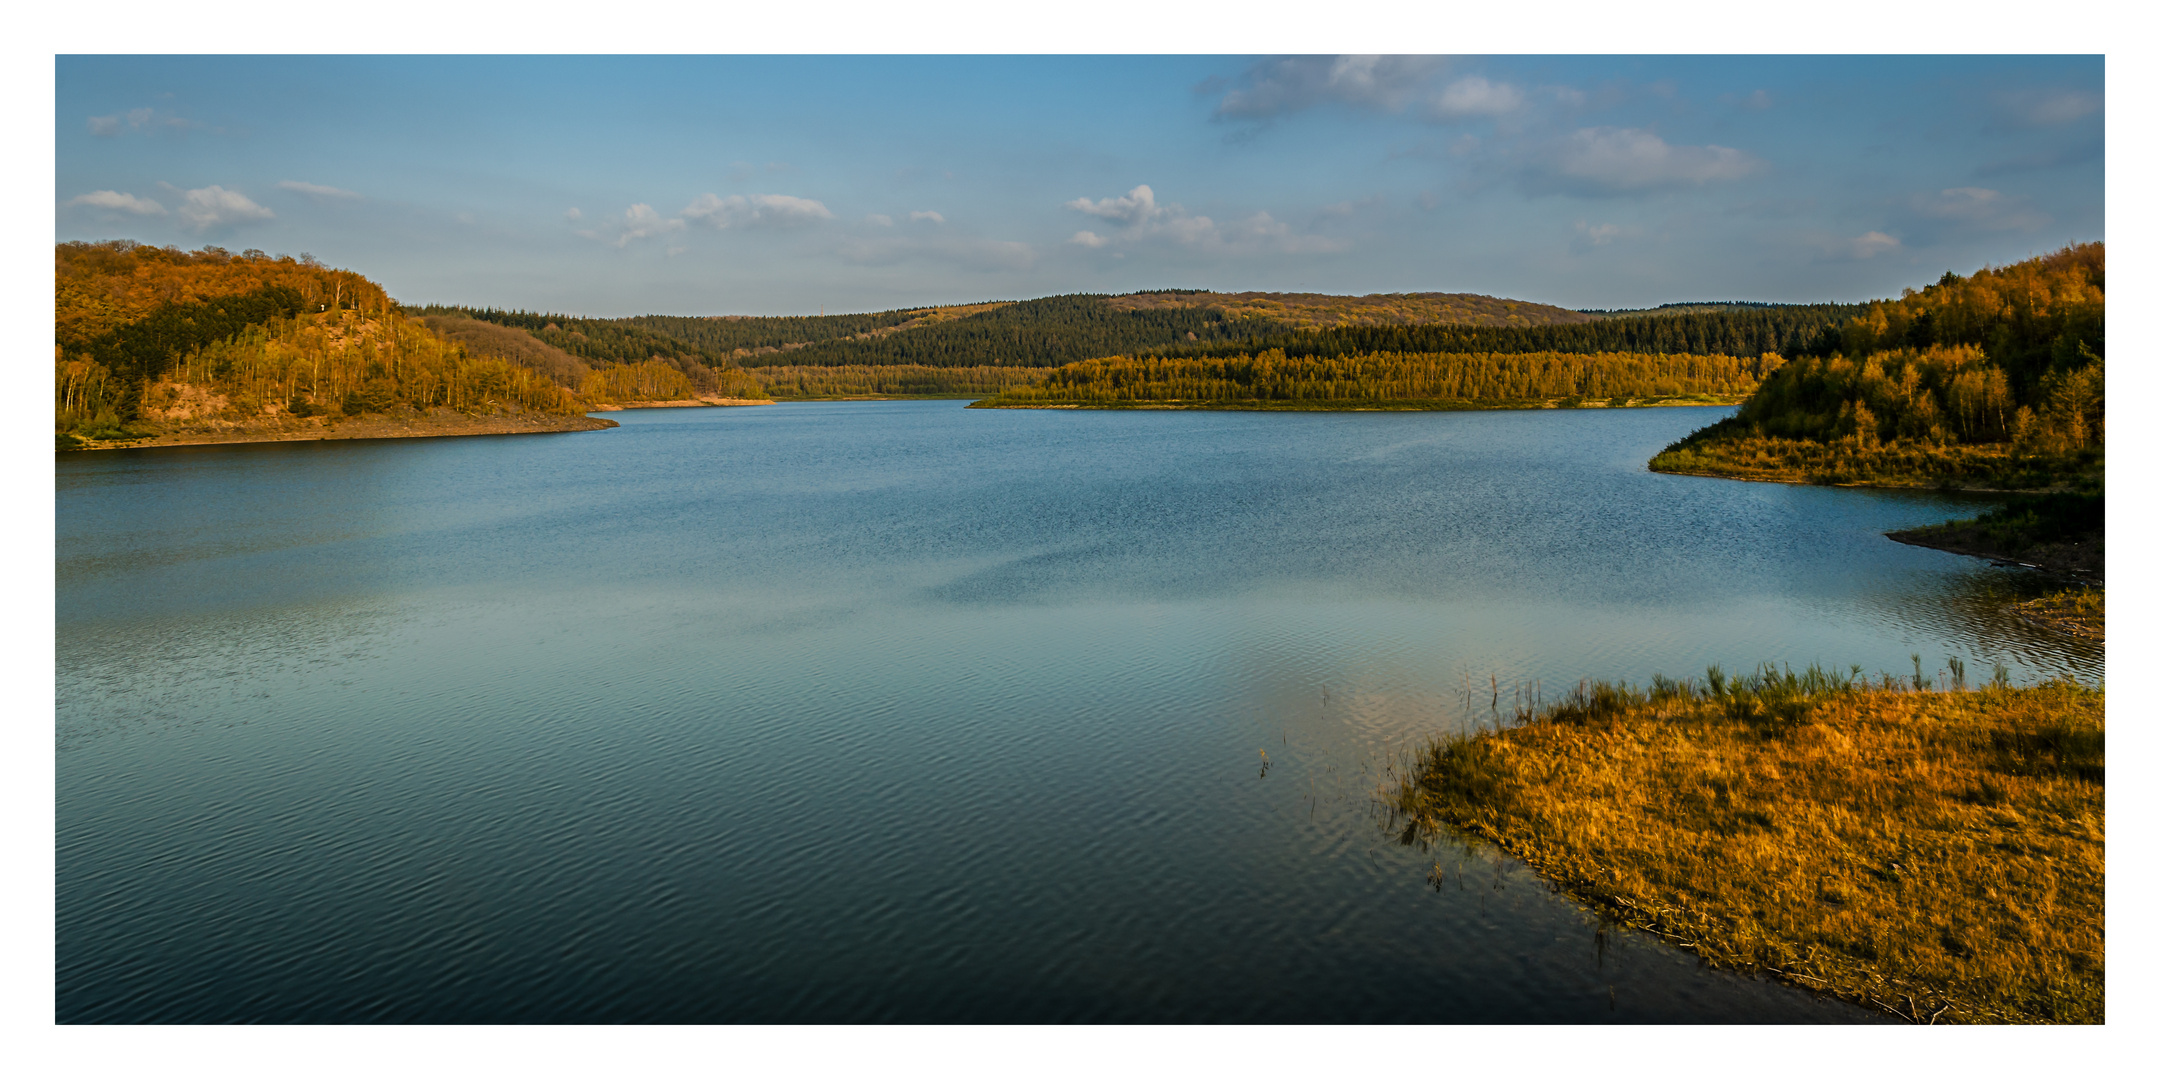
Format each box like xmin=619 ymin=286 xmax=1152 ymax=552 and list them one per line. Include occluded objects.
xmin=54 ymin=56 xmax=2104 ymax=315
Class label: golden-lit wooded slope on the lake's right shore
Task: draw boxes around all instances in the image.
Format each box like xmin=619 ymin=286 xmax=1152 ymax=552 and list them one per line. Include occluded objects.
xmin=1650 ymin=244 xmax=2106 ymax=488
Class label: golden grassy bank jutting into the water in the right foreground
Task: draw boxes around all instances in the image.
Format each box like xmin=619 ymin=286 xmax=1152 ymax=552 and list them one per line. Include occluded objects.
xmin=1393 ymin=657 xmax=2106 ymax=1024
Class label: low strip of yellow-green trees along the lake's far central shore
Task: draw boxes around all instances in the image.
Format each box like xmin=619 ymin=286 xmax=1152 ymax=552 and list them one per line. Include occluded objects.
xmin=974 ymin=350 xmax=1782 ymax=408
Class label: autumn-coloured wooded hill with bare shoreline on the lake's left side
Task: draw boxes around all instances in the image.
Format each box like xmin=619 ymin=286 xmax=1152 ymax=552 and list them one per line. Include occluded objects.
xmin=54 ymin=240 xmax=765 ymax=447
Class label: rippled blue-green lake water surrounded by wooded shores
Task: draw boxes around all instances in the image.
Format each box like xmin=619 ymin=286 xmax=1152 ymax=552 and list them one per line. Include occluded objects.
xmin=56 ymin=402 xmax=2102 ymax=1024
